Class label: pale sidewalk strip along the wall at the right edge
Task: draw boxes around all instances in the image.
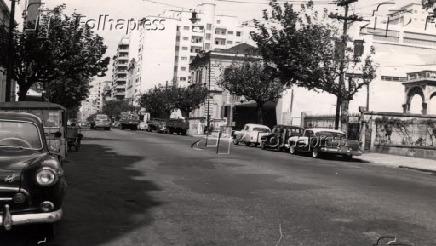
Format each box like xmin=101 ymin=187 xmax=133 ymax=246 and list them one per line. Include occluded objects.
xmin=355 ymin=153 xmax=436 ymax=174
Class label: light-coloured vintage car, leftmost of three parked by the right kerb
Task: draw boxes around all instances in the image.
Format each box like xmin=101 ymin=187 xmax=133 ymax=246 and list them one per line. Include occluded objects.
xmin=232 ymin=123 xmax=271 ymax=146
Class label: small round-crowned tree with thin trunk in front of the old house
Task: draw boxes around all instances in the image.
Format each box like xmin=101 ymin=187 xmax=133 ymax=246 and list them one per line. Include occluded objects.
xmin=218 ymin=59 xmax=285 ymax=124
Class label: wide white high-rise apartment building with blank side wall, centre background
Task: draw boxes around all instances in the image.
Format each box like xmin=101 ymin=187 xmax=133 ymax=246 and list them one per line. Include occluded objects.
xmin=135 ymin=0 xmax=255 ymax=102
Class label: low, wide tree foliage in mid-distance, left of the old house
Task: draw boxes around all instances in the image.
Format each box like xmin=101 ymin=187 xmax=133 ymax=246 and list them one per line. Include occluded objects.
xmin=140 ymin=84 xmax=208 ymax=118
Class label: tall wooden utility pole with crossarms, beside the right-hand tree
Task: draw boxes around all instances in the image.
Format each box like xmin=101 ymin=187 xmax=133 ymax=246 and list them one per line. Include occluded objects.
xmin=329 ymin=0 xmax=363 ymax=129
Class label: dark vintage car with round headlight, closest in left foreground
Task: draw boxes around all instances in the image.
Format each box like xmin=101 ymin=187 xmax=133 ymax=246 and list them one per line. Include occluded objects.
xmin=0 ymin=111 xmax=66 ymax=237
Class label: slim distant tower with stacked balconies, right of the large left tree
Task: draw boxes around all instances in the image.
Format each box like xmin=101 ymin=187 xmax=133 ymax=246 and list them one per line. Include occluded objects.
xmin=112 ymin=37 xmax=130 ymax=100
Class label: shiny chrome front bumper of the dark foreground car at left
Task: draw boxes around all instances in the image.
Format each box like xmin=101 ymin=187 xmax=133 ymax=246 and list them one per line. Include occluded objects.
xmin=0 ymin=206 xmax=63 ymax=230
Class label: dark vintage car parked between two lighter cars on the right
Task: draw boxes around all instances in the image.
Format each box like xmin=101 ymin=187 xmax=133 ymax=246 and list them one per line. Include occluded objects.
xmin=260 ymin=125 xmax=303 ymax=151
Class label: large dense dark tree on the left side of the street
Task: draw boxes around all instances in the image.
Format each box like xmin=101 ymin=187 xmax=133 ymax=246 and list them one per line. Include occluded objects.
xmin=14 ymin=5 xmax=109 ymax=100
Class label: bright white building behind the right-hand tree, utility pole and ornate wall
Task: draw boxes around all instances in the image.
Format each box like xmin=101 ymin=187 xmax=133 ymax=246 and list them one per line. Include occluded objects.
xmin=286 ymin=3 xmax=436 ymax=123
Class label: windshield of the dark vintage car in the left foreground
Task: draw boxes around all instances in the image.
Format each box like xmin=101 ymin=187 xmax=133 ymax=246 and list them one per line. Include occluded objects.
xmin=0 ymin=121 xmax=42 ymax=149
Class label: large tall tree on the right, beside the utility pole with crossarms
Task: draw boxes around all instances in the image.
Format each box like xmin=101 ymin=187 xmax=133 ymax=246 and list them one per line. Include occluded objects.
xmin=252 ymin=0 xmax=375 ymax=131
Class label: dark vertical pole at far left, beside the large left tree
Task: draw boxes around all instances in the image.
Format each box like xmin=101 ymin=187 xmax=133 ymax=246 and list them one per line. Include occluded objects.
xmin=5 ymin=0 xmax=16 ymax=102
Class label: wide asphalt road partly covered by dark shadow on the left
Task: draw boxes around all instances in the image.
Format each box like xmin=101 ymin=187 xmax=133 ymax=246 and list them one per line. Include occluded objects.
xmin=0 ymin=129 xmax=436 ymax=246
